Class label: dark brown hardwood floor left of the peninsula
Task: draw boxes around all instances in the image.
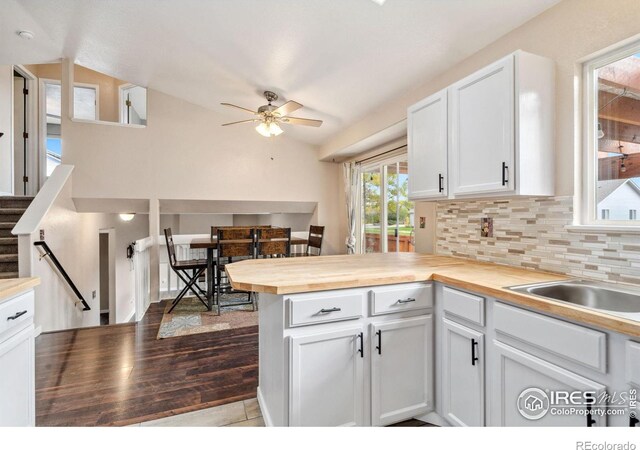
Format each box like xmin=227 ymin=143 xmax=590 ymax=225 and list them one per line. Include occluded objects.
xmin=36 ymin=302 xmax=258 ymax=426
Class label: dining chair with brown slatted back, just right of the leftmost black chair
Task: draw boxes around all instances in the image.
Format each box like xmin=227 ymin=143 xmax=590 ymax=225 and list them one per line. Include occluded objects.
xmin=215 ymin=227 xmax=256 ymax=314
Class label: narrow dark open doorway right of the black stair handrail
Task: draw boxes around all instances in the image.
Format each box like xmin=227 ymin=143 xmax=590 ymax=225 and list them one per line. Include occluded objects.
xmin=98 ymin=229 xmax=116 ymax=325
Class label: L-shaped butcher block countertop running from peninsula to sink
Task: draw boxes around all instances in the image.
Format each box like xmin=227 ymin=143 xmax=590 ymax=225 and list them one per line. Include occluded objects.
xmin=226 ymin=253 xmax=640 ymax=337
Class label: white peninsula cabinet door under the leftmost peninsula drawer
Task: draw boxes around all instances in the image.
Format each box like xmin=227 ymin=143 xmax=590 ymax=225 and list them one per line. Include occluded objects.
xmin=289 ymin=326 xmax=364 ymax=427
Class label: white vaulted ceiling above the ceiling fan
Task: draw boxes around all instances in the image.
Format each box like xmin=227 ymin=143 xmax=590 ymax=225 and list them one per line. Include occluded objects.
xmin=0 ymin=0 xmax=559 ymax=144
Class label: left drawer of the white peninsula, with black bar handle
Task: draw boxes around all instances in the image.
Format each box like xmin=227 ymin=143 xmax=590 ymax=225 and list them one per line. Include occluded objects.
xmin=287 ymin=291 xmax=364 ymax=327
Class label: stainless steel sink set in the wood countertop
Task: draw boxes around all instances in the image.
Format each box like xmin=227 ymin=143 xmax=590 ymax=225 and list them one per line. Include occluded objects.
xmin=509 ymin=280 xmax=640 ymax=320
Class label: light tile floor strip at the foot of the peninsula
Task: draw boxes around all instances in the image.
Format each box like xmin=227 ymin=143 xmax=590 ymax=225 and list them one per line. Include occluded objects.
xmin=130 ymin=398 xmax=264 ymax=427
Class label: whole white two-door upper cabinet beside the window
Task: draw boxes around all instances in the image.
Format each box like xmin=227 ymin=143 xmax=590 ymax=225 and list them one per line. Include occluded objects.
xmin=407 ymin=51 xmax=555 ymax=199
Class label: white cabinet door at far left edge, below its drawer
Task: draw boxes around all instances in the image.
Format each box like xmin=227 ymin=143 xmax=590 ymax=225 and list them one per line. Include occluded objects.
xmin=0 ymin=326 xmax=35 ymax=427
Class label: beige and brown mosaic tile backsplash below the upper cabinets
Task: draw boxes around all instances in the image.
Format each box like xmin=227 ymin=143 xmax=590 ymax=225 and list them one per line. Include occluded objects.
xmin=436 ymin=197 xmax=640 ymax=284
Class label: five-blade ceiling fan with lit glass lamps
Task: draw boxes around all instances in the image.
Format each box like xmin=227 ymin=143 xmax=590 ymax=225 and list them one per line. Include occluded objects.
xmin=221 ymin=91 xmax=322 ymax=137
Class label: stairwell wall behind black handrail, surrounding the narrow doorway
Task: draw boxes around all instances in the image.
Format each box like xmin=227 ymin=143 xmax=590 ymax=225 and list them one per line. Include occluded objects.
xmin=28 ymin=176 xmax=149 ymax=331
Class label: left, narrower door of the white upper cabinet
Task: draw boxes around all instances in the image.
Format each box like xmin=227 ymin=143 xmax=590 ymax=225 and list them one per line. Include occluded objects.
xmin=407 ymin=89 xmax=449 ymax=199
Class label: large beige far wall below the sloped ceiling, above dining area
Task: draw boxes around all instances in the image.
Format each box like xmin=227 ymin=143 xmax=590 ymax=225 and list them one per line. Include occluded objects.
xmin=62 ymin=68 xmax=344 ymax=253
